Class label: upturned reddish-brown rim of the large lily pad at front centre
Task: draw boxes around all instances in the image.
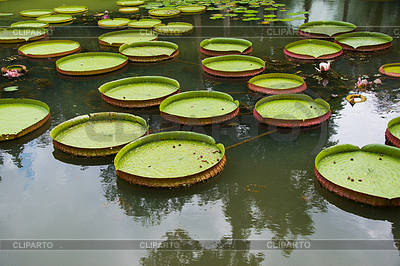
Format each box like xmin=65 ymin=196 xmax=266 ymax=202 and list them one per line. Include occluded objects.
xmin=114 ymin=131 xmax=226 ymax=188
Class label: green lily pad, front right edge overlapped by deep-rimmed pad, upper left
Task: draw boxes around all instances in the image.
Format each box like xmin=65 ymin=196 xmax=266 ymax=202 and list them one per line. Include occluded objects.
xmin=99 ymin=29 xmax=158 ymax=47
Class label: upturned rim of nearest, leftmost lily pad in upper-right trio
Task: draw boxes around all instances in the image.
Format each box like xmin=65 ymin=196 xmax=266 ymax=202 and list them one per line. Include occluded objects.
xmin=284 ymin=39 xmax=343 ymax=60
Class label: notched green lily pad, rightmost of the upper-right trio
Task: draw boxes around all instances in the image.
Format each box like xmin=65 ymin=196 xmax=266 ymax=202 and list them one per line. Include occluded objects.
xmin=335 ymin=32 xmax=393 ymax=49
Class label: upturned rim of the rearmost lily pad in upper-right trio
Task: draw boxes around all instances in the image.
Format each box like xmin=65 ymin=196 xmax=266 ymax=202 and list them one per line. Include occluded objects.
xmin=297 ymin=20 xmax=357 ymax=39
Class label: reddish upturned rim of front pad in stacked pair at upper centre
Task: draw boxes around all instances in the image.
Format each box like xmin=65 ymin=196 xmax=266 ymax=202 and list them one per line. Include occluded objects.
xmin=201 ymin=55 xmax=265 ymax=77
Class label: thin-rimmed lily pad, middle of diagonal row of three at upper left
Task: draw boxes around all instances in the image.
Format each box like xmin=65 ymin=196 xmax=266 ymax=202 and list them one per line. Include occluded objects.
xmin=18 ymin=40 xmax=81 ymax=58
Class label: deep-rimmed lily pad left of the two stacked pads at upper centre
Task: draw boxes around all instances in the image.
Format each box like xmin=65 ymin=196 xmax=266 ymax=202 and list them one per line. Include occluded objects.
xmin=119 ymin=41 xmax=179 ymax=62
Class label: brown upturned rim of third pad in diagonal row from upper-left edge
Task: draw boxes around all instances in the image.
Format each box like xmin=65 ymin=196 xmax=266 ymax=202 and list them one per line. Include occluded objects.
xmin=56 ymin=52 xmax=129 ymax=76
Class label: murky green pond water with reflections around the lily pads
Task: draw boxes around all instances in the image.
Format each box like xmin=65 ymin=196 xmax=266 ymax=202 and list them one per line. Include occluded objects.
xmin=0 ymin=0 xmax=400 ymax=265
